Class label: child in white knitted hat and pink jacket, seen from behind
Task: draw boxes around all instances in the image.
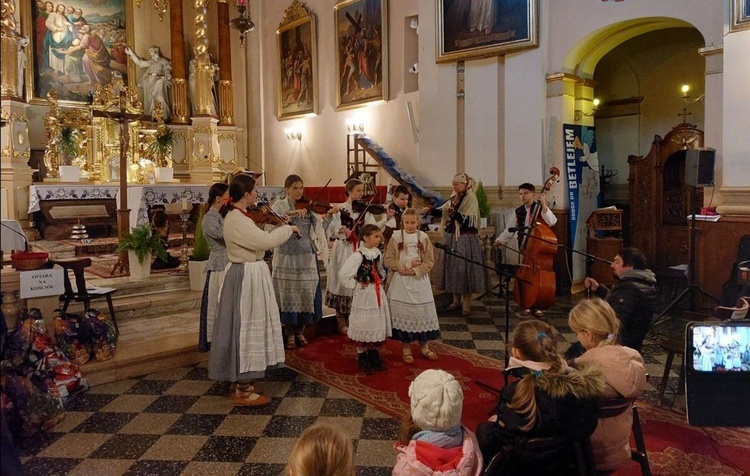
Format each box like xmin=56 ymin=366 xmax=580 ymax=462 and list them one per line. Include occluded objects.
xmin=392 ymin=369 xmax=482 ymax=476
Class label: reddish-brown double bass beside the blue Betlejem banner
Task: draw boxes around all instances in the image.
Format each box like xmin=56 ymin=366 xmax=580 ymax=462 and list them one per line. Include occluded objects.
xmin=513 ymin=167 xmax=560 ymax=309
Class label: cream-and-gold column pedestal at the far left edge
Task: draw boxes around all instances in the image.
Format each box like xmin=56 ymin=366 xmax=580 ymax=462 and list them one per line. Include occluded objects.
xmin=0 ymin=102 xmax=32 ymax=221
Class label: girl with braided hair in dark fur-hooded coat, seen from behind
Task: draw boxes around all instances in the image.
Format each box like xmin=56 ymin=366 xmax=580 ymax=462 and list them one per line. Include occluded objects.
xmin=477 ymin=319 xmax=606 ymax=474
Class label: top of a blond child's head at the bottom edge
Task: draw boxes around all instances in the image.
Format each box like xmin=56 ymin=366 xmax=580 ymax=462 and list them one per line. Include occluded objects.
xmin=282 ymin=423 xmax=357 ymax=476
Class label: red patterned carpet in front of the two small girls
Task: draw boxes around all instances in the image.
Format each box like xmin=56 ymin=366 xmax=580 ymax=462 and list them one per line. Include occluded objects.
xmin=286 ymin=335 xmax=503 ymax=429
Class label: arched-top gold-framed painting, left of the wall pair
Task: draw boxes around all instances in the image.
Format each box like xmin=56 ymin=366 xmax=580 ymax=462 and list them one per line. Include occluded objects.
xmin=276 ymin=0 xmax=318 ymax=119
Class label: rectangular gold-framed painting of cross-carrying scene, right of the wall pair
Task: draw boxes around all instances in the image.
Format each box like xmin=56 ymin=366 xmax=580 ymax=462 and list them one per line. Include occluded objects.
xmin=333 ymin=0 xmax=388 ymax=110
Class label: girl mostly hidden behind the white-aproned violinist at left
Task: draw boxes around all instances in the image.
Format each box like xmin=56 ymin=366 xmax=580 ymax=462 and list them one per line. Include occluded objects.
xmin=198 ymin=182 xmax=229 ymax=352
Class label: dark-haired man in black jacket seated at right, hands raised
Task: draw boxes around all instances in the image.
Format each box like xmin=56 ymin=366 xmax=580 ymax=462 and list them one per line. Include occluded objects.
xmin=585 ymin=248 xmax=656 ymax=352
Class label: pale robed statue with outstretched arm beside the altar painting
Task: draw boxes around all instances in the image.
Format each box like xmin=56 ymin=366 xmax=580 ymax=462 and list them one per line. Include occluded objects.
xmin=125 ymin=46 xmax=172 ymax=121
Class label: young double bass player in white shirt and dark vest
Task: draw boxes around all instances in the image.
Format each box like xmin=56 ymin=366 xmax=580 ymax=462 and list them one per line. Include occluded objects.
xmin=495 ymin=182 xmax=557 ymax=317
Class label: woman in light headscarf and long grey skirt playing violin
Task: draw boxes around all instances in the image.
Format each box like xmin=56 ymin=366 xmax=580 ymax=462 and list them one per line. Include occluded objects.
xmin=425 ymin=173 xmax=490 ymax=316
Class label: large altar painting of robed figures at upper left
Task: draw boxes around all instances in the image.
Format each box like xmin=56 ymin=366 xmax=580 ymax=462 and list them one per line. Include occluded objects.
xmin=21 ymin=0 xmax=135 ymax=105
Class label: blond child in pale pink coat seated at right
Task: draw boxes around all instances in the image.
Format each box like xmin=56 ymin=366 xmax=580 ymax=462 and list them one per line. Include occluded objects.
xmin=568 ymin=299 xmax=646 ymax=471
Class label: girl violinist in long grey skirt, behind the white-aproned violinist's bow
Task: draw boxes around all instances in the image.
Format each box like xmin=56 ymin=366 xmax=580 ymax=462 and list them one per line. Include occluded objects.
xmin=271 ymin=175 xmax=328 ymax=349
